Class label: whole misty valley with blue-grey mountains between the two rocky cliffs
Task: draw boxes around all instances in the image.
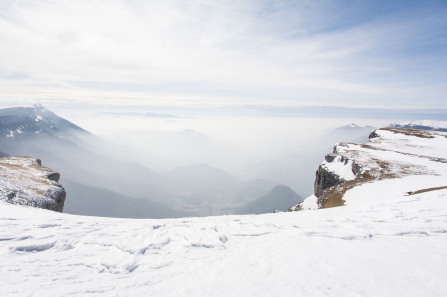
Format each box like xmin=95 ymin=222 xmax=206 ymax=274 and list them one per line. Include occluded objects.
xmin=0 ymin=105 xmax=388 ymax=218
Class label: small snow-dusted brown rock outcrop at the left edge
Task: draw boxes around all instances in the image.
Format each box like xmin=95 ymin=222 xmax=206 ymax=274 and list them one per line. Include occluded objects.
xmin=0 ymin=157 xmax=66 ymax=212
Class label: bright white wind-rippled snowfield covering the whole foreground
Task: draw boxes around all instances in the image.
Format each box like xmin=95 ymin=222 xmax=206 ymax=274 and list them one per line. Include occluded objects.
xmin=0 ymin=131 xmax=447 ymax=297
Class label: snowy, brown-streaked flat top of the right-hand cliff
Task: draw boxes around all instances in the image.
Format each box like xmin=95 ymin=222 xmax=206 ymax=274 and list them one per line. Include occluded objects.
xmin=332 ymin=129 xmax=447 ymax=180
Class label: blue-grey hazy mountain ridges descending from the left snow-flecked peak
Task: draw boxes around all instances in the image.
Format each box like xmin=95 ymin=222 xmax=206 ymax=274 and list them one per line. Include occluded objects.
xmin=0 ymin=105 xmax=302 ymax=218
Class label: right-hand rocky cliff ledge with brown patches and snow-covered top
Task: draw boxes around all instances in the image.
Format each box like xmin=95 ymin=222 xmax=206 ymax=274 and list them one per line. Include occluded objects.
xmin=289 ymin=128 xmax=447 ymax=211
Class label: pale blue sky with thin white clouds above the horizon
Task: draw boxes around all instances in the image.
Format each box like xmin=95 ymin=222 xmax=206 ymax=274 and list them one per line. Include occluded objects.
xmin=0 ymin=0 xmax=447 ymax=120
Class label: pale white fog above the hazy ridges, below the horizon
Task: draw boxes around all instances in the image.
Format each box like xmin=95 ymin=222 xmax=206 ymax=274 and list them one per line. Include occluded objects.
xmin=98 ymin=117 xmax=377 ymax=196
